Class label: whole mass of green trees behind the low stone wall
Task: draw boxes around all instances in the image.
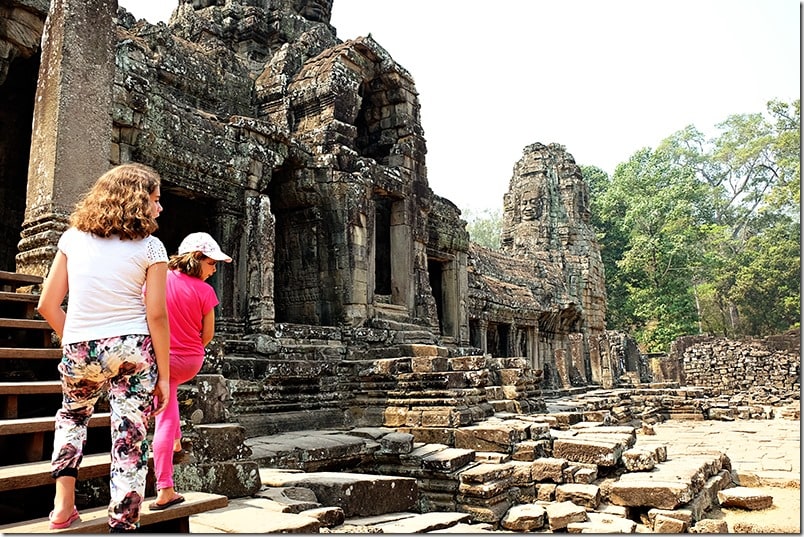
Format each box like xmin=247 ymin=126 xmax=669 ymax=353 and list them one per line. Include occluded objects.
xmin=583 ymin=101 xmax=801 ymax=351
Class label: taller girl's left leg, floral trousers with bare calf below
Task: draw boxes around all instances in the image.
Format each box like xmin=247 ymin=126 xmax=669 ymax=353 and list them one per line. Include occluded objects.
xmin=51 ymin=341 xmax=106 ymax=522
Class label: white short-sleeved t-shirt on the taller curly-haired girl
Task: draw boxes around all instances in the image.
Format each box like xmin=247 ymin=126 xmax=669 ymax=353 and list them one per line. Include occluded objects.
xmin=58 ymin=227 xmax=168 ymax=344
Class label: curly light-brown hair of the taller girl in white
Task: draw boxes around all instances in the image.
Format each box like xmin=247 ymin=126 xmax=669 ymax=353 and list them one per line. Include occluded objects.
xmin=70 ymin=162 xmax=161 ymax=239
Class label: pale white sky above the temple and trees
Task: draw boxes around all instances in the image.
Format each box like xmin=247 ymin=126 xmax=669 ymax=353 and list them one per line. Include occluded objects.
xmin=119 ymin=0 xmax=801 ymax=211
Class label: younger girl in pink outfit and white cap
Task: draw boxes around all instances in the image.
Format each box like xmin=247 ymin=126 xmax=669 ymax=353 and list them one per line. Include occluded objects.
xmin=146 ymin=233 xmax=232 ymax=510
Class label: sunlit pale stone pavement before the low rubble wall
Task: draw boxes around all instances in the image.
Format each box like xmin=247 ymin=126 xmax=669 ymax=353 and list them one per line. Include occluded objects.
xmin=637 ymin=418 xmax=801 ymax=487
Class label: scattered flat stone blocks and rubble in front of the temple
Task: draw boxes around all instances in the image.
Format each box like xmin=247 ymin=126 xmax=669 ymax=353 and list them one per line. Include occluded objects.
xmin=187 ymin=406 xmax=772 ymax=533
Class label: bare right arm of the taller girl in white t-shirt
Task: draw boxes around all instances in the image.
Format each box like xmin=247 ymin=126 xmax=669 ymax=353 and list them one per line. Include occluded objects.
xmin=145 ymin=262 xmax=170 ymax=416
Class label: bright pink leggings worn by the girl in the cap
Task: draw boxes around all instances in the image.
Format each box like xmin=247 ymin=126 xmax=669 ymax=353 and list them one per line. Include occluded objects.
xmin=153 ymin=354 xmax=204 ymax=489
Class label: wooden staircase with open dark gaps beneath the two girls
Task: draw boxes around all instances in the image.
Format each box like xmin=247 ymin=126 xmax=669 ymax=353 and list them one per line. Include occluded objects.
xmin=0 ymin=271 xmax=227 ymax=533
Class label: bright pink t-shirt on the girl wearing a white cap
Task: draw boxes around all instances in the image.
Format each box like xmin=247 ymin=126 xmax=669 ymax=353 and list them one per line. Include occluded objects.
xmin=166 ymin=270 xmax=218 ymax=356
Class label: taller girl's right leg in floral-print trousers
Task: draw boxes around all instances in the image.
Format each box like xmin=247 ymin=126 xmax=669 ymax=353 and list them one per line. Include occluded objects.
xmin=103 ymin=335 xmax=157 ymax=532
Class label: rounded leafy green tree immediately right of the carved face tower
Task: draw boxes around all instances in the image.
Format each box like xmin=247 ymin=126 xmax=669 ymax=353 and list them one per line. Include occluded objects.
xmin=595 ymin=148 xmax=701 ymax=351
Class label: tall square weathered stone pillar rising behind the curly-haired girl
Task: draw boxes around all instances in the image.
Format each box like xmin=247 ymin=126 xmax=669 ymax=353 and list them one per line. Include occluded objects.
xmin=16 ymin=0 xmax=117 ymax=276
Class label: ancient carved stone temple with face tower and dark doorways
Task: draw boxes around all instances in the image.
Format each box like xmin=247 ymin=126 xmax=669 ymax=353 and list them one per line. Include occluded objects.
xmin=0 ymin=0 xmax=620 ymax=433
